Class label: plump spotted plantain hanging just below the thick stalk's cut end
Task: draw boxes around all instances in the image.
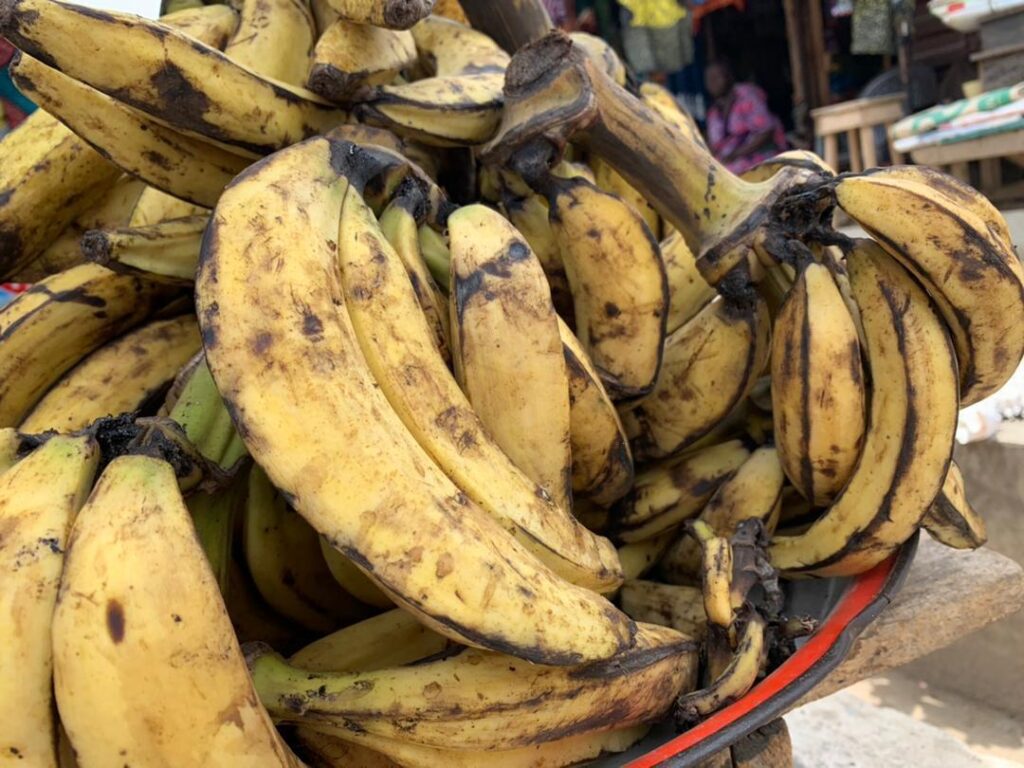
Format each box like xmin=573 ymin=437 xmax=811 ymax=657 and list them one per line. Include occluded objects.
xmin=529 ymin=175 xmax=669 ymax=398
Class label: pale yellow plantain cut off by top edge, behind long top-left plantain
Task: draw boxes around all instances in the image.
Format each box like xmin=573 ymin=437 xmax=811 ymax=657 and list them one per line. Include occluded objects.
xmin=225 ymin=0 xmax=316 ymax=86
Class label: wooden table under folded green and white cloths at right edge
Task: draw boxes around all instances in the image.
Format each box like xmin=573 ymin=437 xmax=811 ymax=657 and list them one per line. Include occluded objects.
xmin=910 ymin=130 xmax=1024 ymax=201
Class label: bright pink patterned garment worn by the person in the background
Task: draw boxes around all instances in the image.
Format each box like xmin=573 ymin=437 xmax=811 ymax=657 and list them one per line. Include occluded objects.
xmin=708 ymin=83 xmax=786 ymax=173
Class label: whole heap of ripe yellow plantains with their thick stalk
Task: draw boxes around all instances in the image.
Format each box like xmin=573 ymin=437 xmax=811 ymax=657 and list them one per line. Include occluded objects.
xmin=0 ymin=0 xmax=1024 ymax=768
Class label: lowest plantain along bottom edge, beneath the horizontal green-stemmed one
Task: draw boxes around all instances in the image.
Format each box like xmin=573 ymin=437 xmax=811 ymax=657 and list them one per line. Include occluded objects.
xmin=298 ymin=725 xmax=650 ymax=768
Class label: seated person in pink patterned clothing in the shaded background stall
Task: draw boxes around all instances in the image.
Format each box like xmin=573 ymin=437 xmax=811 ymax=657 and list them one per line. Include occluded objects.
xmin=705 ymin=61 xmax=786 ymax=173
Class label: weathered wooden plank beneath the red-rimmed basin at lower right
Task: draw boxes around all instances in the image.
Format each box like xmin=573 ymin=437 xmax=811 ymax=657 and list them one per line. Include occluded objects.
xmin=797 ymin=536 xmax=1024 ymax=707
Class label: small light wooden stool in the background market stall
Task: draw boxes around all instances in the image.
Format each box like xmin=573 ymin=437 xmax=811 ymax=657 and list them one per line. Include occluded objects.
xmin=811 ymin=93 xmax=904 ymax=172
